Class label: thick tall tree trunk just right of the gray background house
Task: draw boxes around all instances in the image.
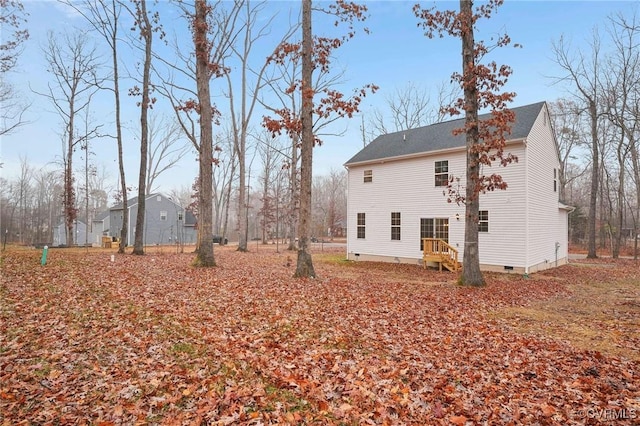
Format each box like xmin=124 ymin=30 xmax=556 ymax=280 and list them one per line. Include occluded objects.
xmin=193 ymin=0 xmax=216 ymax=267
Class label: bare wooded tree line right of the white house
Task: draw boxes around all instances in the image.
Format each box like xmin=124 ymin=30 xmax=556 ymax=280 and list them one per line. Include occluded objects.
xmin=551 ymin=10 xmax=640 ymax=258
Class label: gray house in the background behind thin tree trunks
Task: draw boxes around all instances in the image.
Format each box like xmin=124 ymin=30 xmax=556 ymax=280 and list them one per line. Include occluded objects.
xmin=109 ymin=194 xmax=197 ymax=245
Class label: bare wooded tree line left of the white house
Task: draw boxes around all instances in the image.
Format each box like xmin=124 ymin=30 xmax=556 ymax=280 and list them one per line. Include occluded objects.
xmin=2 ymin=0 xmax=368 ymax=275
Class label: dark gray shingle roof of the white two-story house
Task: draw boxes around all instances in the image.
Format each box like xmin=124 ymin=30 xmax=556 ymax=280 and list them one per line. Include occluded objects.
xmin=345 ymin=102 xmax=545 ymax=166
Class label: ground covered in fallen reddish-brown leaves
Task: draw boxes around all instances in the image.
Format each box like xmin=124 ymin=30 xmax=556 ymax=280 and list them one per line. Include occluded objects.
xmin=0 ymin=246 xmax=640 ymax=425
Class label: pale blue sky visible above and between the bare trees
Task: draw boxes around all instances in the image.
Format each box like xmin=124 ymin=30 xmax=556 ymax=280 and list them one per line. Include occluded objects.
xmin=0 ymin=0 xmax=638 ymax=192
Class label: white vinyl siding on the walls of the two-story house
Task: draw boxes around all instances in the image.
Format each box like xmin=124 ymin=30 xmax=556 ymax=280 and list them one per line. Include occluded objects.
xmin=347 ymin=103 xmax=567 ymax=269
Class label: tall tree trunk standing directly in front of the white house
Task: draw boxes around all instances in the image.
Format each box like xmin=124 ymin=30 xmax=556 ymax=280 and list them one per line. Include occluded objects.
xmin=460 ymin=0 xmax=485 ymax=286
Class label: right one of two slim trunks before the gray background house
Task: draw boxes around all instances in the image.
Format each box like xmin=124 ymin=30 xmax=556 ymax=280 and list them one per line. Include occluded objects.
xmin=132 ymin=0 xmax=153 ymax=255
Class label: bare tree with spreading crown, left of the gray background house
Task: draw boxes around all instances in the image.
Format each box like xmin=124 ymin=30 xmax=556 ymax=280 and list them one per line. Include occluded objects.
xmin=40 ymin=32 xmax=104 ymax=245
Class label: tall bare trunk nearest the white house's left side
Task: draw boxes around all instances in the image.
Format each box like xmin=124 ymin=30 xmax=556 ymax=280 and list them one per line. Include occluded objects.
xmin=294 ymin=0 xmax=316 ymax=277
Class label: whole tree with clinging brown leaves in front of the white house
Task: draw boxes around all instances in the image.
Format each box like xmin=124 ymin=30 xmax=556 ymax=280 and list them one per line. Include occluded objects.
xmin=413 ymin=0 xmax=519 ymax=286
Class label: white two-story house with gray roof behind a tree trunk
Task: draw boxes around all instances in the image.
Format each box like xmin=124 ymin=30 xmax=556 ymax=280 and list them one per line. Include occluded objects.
xmin=345 ymin=102 xmax=572 ymax=273
